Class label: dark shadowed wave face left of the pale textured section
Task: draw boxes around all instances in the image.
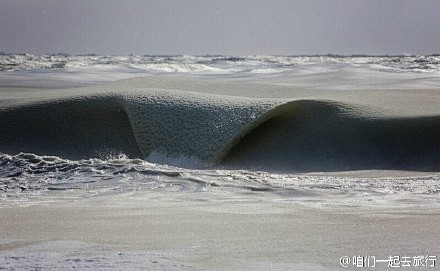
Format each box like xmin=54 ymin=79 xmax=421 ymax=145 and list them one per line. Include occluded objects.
xmin=0 ymin=97 xmax=141 ymax=159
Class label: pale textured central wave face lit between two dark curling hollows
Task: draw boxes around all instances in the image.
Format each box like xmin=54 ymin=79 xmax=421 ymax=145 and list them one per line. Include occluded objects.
xmin=120 ymin=90 xmax=279 ymax=163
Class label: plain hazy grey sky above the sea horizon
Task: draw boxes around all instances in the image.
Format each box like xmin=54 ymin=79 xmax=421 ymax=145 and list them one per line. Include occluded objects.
xmin=0 ymin=0 xmax=440 ymax=55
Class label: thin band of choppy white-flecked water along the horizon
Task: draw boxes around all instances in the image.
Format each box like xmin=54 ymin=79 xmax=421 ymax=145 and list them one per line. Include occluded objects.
xmin=0 ymin=53 xmax=440 ymax=74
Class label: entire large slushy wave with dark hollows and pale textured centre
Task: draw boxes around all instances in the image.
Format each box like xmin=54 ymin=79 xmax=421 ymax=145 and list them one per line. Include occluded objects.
xmin=0 ymin=86 xmax=440 ymax=171
